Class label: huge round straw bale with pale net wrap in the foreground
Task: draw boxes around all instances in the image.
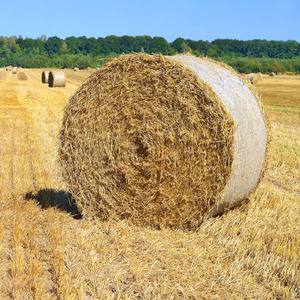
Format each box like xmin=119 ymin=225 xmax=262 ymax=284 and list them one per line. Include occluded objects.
xmin=59 ymin=53 xmax=267 ymax=228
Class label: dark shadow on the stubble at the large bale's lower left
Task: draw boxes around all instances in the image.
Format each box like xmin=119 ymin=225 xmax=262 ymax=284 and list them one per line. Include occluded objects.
xmin=25 ymin=189 xmax=82 ymax=219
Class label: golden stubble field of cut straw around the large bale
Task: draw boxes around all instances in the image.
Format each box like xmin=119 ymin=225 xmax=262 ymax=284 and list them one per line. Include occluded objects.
xmin=0 ymin=69 xmax=300 ymax=300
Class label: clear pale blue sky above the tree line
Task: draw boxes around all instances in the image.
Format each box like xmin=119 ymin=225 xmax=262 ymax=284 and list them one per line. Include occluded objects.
xmin=0 ymin=0 xmax=300 ymax=42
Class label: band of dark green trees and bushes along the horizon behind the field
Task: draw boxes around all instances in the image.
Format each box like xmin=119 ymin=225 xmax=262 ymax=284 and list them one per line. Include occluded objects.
xmin=0 ymin=35 xmax=300 ymax=74
